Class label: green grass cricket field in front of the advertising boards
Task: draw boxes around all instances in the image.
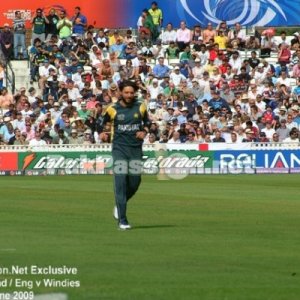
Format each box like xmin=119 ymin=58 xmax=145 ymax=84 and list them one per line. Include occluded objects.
xmin=0 ymin=175 xmax=300 ymax=300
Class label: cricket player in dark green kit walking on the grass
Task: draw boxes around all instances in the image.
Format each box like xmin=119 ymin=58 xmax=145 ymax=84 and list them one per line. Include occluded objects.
xmin=103 ymin=81 xmax=150 ymax=230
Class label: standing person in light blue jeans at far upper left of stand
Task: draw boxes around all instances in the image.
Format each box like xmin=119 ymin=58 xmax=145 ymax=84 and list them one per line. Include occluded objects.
xmin=13 ymin=10 xmax=27 ymax=59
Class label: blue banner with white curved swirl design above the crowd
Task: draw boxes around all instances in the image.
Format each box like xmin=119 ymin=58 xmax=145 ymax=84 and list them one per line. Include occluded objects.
xmin=128 ymin=0 xmax=300 ymax=27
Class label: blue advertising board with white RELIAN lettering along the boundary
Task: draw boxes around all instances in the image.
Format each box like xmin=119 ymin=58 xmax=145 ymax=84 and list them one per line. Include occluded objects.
xmin=214 ymin=150 xmax=300 ymax=174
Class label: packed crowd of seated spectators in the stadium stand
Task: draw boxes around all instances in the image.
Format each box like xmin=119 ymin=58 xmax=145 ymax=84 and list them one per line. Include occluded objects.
xmin=0 ymin=2 xmax=300 ymax=145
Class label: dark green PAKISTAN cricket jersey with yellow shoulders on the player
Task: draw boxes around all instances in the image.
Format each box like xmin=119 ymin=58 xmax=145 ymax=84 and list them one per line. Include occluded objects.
xmin=103 ymin=100 xmax=150 ymax=147
